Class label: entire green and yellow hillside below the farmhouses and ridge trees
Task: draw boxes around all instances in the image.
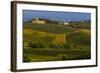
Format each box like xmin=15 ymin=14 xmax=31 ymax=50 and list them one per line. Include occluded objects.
xmin=23 ymin=23 xmax=91 ymax=62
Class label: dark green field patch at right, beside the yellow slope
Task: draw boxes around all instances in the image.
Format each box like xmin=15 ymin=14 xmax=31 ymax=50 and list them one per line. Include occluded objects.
xmin=66 ymin=31 xmax=91 ymax=47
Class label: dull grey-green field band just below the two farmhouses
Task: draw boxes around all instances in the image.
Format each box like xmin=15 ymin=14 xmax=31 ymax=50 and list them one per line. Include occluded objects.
xmin=24 ymin=23 xmax=74 ymax=34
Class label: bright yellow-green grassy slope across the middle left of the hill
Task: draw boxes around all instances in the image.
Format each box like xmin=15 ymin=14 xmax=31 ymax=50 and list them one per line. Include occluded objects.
xmin=23 ymin=29 xmax=66 ymax=43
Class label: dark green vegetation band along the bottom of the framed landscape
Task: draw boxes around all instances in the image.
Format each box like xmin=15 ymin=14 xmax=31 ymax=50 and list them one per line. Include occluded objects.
xmin=23 ymin=48 xmax=91 ymax=62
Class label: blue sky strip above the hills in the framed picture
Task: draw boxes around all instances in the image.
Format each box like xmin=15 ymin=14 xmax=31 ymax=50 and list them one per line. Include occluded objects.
xmin=23 ymin=10 xmax=91 ymax=22
